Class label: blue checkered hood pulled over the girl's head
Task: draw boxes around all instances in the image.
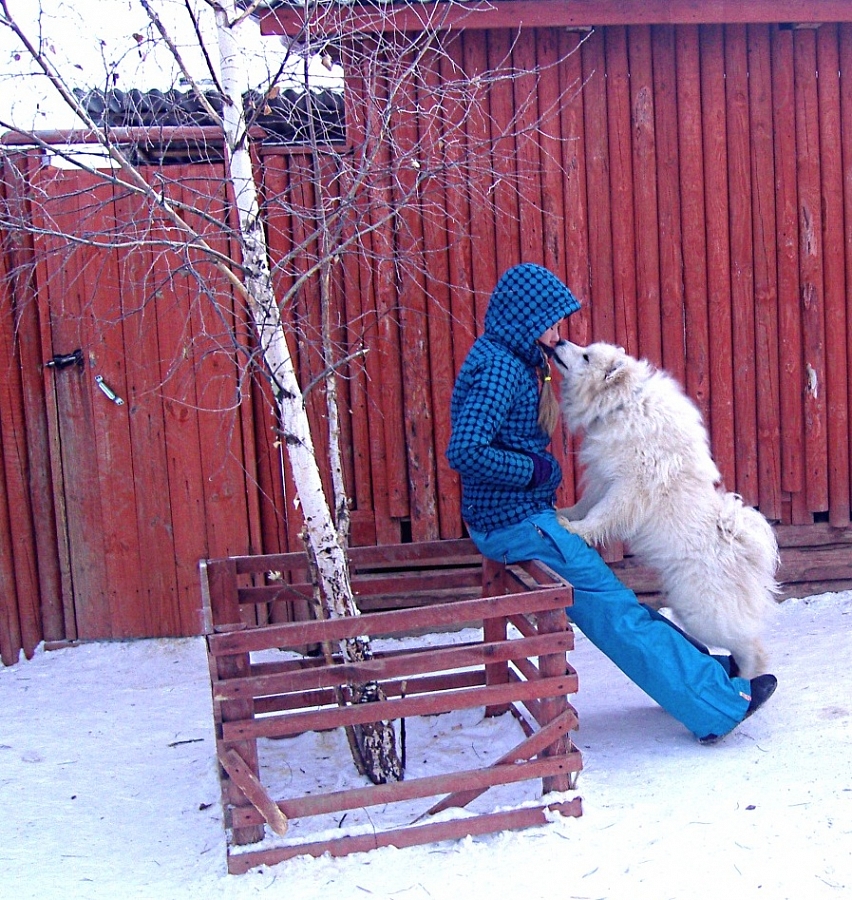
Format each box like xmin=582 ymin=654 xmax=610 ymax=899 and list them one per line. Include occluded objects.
xmin=483 ymin=263 xmax=580 ymax=366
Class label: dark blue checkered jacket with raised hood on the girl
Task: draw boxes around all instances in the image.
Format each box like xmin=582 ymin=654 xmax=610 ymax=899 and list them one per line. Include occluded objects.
xmin=447 ymin=263 xmax=580 ymax=531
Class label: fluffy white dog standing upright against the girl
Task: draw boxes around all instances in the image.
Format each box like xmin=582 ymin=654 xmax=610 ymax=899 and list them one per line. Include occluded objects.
xmin=553 ymin=341 xmax=778 ymax=678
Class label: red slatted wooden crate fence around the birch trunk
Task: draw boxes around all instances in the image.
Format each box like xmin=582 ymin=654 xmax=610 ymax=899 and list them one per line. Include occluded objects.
xmin=201 ymin=540 xmax=582 ymax=873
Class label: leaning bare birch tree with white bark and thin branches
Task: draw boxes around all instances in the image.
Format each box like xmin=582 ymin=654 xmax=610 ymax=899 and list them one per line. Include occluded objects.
xmin=0 ymin=0 xmax=578 ymax=782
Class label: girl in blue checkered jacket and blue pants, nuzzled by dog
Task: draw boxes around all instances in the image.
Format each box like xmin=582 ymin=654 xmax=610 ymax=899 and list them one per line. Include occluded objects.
xmin=447 ymin=263 xmax=777 ymax=743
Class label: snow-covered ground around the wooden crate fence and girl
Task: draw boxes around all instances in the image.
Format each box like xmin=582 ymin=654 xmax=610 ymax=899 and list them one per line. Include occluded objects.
xmin=0 ymin=592 xmax=852 ymax=900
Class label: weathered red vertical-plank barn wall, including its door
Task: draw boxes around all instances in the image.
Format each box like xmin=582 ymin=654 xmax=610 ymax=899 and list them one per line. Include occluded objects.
xmin=0 ymin=19 xmax=852 ymax=662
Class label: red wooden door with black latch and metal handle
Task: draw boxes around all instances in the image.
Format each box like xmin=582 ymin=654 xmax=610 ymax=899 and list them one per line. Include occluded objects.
xmin=36 ymin=163 xmax=256 ymax=639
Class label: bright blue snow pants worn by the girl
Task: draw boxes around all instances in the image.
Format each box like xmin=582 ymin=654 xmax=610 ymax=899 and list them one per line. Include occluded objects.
xmin=468 ymin=510 xmax=751 ymax=738
